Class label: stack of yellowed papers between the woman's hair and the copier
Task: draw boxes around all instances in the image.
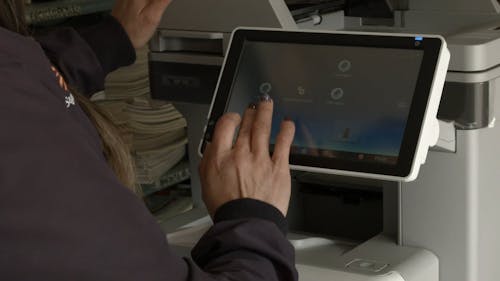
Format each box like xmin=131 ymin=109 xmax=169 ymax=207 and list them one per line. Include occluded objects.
xmin=92 ymin=48 xmax=187 ymax=189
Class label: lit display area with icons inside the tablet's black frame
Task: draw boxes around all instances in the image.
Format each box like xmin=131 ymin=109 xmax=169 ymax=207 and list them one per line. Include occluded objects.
xmin=226 ymin=41 xmax=423 ymax=165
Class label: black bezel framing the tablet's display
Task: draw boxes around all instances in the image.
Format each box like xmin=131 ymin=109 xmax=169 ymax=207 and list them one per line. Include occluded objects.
xmin=200 ymin=29 xmax=442 ymax=177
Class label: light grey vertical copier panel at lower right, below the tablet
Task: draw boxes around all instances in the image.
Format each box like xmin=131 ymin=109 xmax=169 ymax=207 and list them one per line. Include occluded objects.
xmin=401 ymin=101 xmax=500 ymax=281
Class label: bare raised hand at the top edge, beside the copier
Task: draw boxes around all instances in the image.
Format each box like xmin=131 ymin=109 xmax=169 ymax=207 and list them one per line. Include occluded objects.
xmin=111 ymin=0 xmax=171 ymax=49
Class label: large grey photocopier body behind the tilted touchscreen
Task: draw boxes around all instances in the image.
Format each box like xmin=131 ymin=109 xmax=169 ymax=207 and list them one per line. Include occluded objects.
xmin=149 ymin=0 xmax=500 ymax=281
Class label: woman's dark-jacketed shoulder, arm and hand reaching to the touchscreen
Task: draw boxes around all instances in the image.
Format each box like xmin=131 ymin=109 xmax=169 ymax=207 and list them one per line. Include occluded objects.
xmin=0 ymin=20 xmax=297 ymax=281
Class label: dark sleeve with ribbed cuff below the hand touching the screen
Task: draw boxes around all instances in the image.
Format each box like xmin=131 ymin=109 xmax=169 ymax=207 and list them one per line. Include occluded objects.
xmin=189 ymin=199 xmax=298 ymax=281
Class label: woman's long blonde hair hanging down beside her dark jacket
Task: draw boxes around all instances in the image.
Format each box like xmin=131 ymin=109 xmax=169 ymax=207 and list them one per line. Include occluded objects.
xmin=0 ymin=0 xmax=140 ymax=194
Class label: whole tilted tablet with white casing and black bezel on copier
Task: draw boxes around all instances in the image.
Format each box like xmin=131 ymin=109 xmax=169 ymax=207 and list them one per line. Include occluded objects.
xmin=204 ymin=28 xmax=449 ymax=180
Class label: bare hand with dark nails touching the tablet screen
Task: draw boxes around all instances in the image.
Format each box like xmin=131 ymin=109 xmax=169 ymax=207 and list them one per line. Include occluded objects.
xmin=200 ymin=96 xmax=295 ymax=216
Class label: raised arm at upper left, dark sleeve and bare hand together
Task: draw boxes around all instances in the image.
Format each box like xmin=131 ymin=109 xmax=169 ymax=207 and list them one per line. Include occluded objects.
xmin=36 ymin=0 xmax=171 ymax=96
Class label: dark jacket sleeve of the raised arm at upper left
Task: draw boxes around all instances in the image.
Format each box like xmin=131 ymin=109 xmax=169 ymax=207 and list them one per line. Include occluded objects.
xmin=35 ymin=16 xmax=135 ymax=96
